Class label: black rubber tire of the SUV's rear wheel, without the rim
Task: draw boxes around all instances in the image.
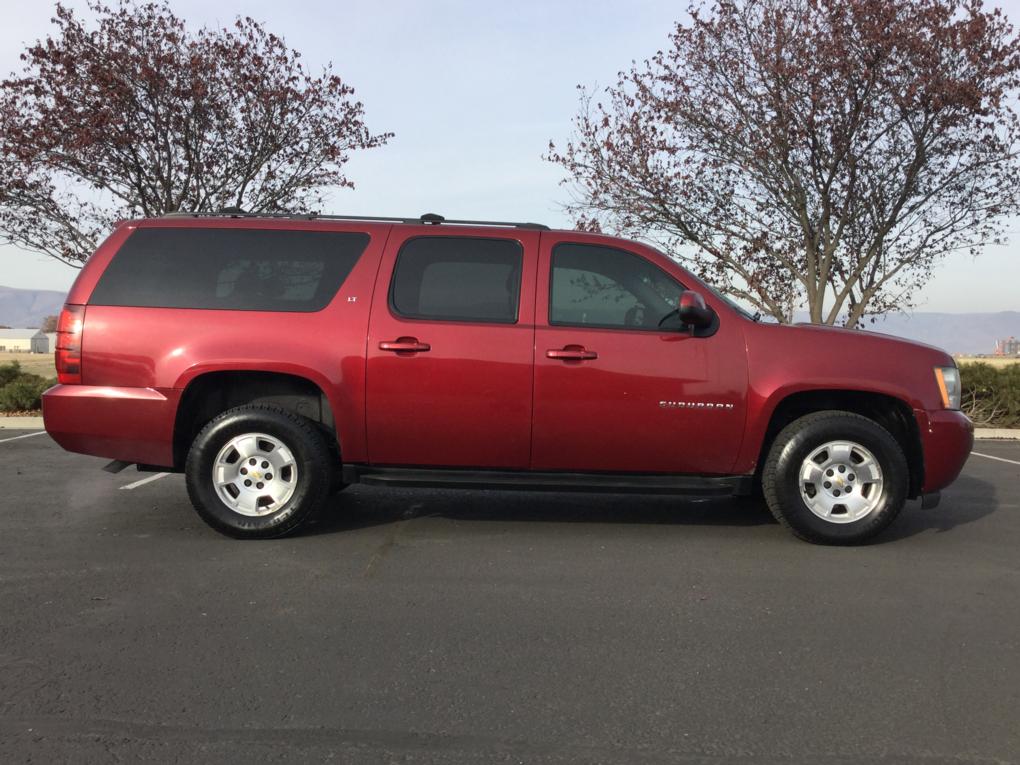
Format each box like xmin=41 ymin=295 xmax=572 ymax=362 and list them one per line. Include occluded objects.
xmin=185 ymin=404 xmax=335 ymax=540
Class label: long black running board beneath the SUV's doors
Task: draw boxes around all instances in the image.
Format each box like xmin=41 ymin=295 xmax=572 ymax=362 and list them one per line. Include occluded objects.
xmin=344 ymin=464 xmax=754 ymax=497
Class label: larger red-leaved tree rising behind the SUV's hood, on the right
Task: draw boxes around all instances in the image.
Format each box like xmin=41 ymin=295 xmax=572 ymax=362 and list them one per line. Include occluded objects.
xmin=548 ymin=0 xmax=1020 ymax=326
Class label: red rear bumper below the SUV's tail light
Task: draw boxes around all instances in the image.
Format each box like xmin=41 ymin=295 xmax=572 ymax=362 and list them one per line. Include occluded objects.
xmin=43 ymin=386 xmax=181 ymax=466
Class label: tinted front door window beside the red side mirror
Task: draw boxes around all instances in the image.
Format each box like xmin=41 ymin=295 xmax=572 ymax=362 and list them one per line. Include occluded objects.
xmin=549 ymin=244 xmax=683 ymax=329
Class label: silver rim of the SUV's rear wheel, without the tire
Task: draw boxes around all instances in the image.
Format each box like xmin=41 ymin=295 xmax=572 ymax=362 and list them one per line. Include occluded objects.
xmin=212 ymin=432 xmax=298 ymax=516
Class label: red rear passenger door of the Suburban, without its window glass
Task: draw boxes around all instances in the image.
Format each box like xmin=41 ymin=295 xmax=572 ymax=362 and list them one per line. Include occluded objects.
xmin=366 ymin=225 xmax=539 ymax=469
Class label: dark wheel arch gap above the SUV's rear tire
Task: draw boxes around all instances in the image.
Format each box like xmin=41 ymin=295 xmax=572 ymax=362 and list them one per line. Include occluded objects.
xmin=173 ymin=368 xmax=340 ymax=469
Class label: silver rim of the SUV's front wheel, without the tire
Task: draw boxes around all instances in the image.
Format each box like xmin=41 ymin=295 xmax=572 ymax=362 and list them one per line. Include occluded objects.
xmin=800 ymin=441 xmax=883 ymax=523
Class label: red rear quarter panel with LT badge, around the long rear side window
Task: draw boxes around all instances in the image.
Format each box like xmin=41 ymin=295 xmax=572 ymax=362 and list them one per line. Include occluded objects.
xmin=55 ymin=219 xmax=390 ymax=465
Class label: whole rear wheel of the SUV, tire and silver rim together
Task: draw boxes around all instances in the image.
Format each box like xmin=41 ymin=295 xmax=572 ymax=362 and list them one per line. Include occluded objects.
xmin=185 ymin=405 xmax=335 ymax=539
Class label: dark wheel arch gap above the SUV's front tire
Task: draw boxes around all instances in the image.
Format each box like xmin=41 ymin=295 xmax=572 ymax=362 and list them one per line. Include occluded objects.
xmin=756 ymin=388 xmax=924 ymax=498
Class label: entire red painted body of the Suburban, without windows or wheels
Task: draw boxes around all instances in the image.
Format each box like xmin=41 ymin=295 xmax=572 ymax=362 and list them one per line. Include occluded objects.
xmin=44 ymin=218 xmax=973 ymax=503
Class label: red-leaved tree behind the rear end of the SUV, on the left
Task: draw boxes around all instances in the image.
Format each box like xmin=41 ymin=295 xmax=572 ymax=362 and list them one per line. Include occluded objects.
xmin=0 ymin=0 xmax=392 ymax=265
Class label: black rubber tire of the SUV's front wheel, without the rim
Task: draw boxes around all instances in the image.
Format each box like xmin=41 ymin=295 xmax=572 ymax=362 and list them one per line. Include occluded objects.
xmin=762 ymin=411 xmax=910 ymax=545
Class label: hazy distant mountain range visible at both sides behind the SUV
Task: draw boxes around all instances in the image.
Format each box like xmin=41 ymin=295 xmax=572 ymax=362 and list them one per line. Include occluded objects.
xmin=0 ymin=287 xmax=1020 ymax=355
